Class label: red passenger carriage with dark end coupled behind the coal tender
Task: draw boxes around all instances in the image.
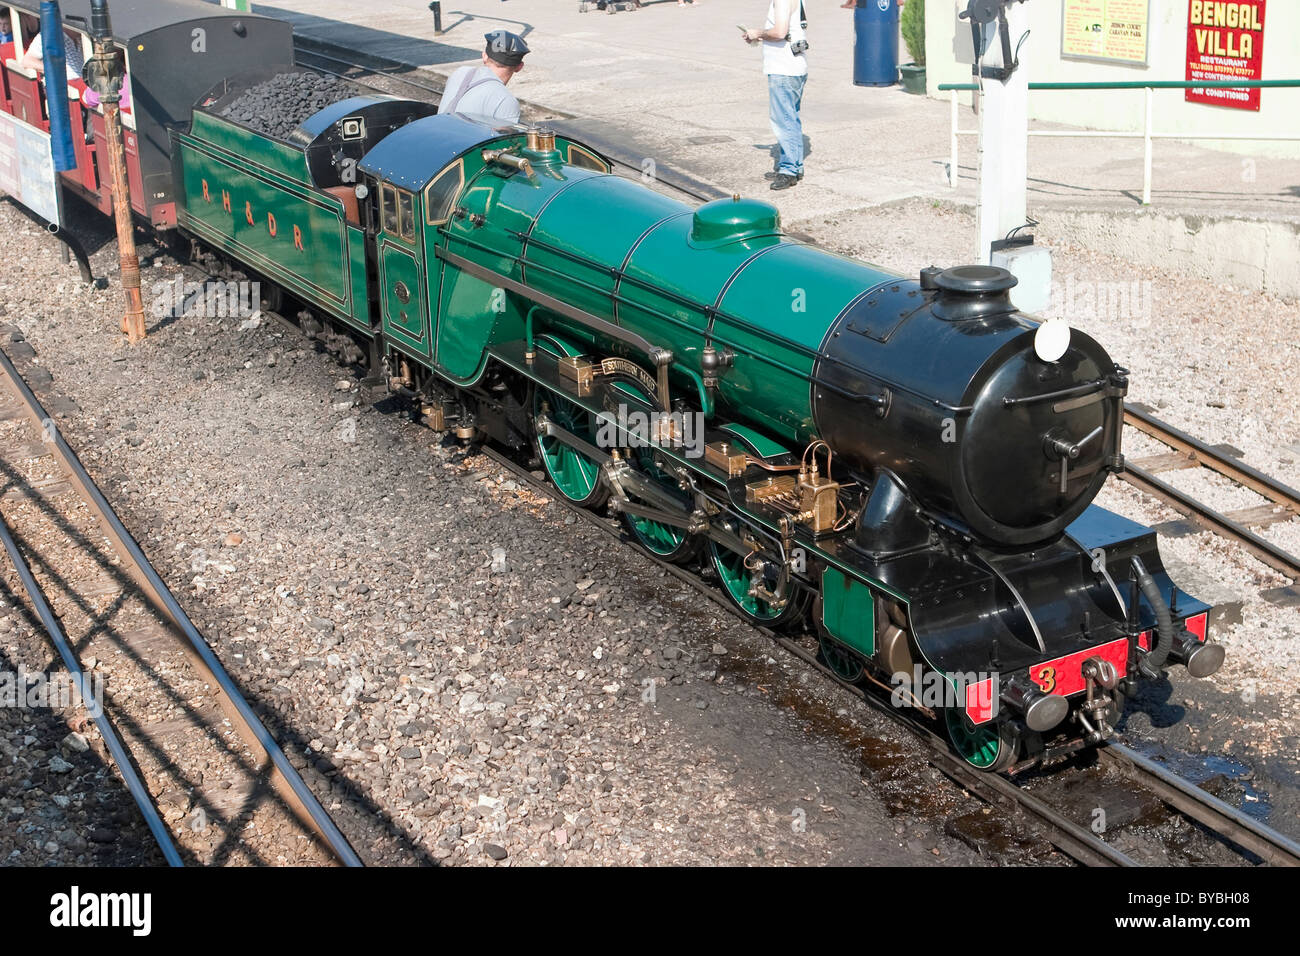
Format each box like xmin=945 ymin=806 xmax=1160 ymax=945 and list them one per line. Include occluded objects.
xmin=0 ymin=0 xmax=294 ymax=229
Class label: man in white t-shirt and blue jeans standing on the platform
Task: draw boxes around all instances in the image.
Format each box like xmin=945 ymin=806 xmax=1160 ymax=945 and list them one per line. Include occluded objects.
xmin=745 ymin=0 xmax=809 ymax=190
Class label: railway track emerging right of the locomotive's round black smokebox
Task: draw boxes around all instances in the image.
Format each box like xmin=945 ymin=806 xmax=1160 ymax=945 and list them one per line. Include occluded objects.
xmin=1121 ymin=405 xmax=1300 ymax=583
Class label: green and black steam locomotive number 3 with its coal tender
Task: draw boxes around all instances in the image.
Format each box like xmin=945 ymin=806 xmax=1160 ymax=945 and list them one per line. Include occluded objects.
xmin=4 ymin=0 xmax=1223 ymax=770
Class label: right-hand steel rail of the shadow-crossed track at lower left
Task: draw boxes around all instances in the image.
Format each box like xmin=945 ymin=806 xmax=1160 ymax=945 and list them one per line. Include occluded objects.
xmin=0 ymin=350 xmax=363 ymax=866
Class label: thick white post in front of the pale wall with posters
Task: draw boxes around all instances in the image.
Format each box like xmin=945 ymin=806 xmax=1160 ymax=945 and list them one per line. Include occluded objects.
xmin=975 ymin=4 xmax=1030 ymax=264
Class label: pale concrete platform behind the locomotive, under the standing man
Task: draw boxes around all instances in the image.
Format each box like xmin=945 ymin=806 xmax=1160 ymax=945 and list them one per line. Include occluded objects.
xmin=255 ymin=0 xmax=1300 ymax=298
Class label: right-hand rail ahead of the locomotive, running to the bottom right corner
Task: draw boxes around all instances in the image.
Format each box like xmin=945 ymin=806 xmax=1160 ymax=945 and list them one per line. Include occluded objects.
xmin=1097 ymin=741 xmax=1300 ymax=866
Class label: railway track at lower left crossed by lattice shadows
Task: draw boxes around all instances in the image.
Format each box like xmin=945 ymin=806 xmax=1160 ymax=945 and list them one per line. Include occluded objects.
xmin=0 ymin=352 xmax=360 ymax=866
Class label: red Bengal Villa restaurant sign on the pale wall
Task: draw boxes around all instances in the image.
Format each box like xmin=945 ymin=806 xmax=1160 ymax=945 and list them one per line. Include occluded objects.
xmin=1186 ymin=0 xmax=1265 ymax=109
